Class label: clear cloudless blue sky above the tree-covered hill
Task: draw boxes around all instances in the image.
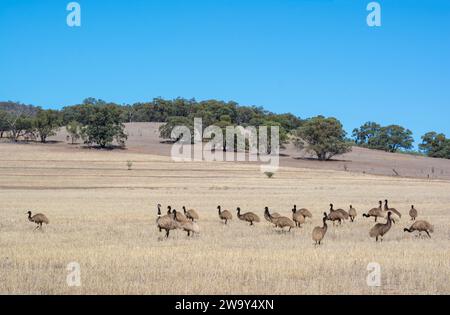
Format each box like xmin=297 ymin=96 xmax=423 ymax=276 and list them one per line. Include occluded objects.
xmin=0 ymin=0 xmax=450 ymax=144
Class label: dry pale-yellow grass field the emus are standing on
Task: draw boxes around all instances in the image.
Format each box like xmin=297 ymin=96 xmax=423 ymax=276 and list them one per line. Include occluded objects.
xmin=0 ymin=143 xmax=450 ymax=294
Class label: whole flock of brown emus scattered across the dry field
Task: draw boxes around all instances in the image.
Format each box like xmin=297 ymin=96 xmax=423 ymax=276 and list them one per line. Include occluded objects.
xmin=27 ymin=200 xmax=434 ymax=245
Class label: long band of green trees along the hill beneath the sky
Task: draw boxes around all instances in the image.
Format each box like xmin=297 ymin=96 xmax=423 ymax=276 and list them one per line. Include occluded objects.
xmin=0 ymin=98 xmax=450 ymax=160
